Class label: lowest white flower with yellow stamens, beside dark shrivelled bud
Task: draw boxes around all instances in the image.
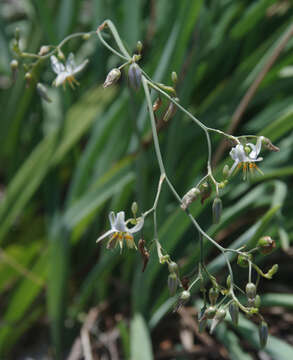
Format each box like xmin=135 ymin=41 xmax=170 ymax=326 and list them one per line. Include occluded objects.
xmin=97 ymin=211 xmax=144 ymax=250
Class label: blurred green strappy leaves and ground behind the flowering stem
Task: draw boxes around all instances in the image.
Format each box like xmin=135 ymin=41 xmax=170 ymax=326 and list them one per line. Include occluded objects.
xmin=0 ymin=0 xmax=293 ymax=360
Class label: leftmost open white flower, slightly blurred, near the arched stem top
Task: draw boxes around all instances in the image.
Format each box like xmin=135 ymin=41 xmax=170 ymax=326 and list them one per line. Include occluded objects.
xmin=50 ymin=53 xmax=88 ymax=89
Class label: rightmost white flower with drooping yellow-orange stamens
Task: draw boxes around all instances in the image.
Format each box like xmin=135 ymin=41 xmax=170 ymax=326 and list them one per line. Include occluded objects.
xmin=229 ymin=136 xmax=263 ymax=178
